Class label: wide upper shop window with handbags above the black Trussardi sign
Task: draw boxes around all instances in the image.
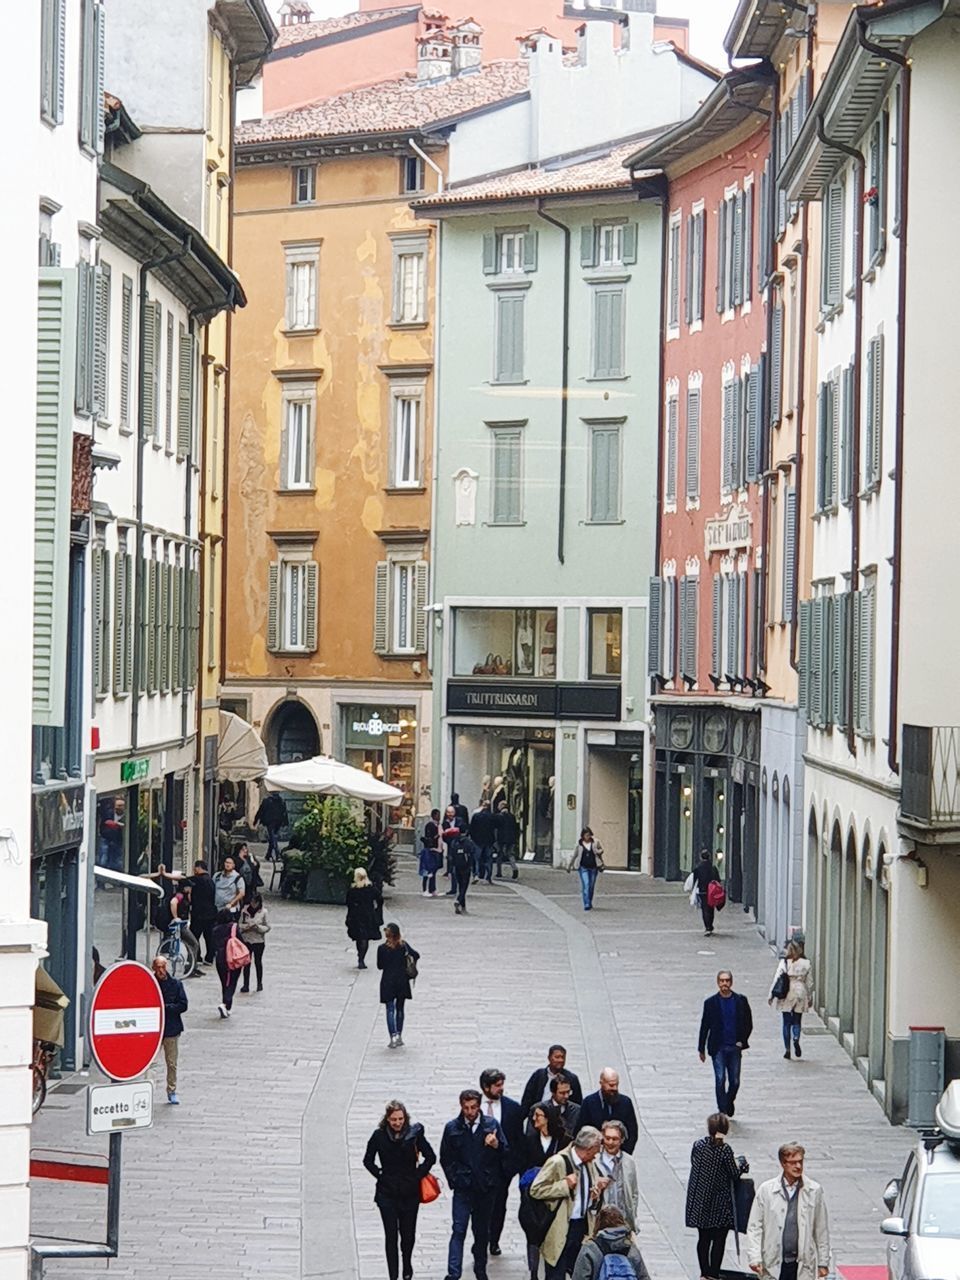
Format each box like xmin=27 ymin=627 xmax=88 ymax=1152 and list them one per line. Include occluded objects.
xmin=453 ymin=609 xmax=557 ymax=680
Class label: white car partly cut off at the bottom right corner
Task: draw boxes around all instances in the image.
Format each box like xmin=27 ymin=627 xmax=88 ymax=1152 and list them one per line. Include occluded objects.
xmin=881 ymin=1080 xmax=960 ymax=1280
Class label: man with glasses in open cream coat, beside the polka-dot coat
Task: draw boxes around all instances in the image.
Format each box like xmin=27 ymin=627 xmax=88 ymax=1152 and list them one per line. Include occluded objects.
xmin=746 ymin=1142 xmax=829 ymax=1280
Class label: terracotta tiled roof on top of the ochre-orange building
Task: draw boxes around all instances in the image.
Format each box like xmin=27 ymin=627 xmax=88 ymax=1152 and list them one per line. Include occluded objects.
xmin=237 ymin=59 xmax=529 ymax=146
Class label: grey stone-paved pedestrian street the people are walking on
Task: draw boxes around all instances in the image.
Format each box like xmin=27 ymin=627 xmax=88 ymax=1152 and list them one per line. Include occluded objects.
xmin=33 ymin=860 xmax=910 ymax=1280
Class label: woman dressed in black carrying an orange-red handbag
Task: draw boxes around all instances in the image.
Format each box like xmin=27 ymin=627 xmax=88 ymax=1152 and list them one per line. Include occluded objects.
xmin=364 ymin=1101 xmax=436 ymax=1280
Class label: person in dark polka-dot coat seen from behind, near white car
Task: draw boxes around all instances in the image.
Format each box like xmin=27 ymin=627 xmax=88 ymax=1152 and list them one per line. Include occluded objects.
xmin=685 ymin=1112 xmax=750 ymax=1280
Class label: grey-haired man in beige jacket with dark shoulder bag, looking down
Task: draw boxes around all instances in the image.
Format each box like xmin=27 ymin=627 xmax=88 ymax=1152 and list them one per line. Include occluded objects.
xmin=530 ymin=1125 xmax=603 ymax=1280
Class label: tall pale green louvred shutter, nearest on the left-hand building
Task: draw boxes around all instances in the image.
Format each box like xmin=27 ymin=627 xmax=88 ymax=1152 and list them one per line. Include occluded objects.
xmin=33 ymin=266 xmax=77 ymax=726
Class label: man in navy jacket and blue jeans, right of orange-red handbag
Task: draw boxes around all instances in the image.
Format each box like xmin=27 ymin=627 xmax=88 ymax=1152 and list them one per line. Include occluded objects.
xmin=440 ymin=1089 xmax=509 ymax=1280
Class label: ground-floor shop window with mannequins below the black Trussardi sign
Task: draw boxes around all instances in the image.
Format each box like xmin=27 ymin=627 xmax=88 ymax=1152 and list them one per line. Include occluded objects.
xmin=453 ymin=724 xmax=556 ymax=861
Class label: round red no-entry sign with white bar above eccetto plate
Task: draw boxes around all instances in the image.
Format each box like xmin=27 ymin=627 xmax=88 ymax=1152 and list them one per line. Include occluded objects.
xmin=90 ymin=960 xmax=164 ymax=1080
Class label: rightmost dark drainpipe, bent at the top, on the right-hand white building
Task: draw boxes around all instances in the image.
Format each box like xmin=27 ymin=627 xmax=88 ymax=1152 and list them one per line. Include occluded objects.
xmin=856 ymin=22 xmax=911 ymax=773
